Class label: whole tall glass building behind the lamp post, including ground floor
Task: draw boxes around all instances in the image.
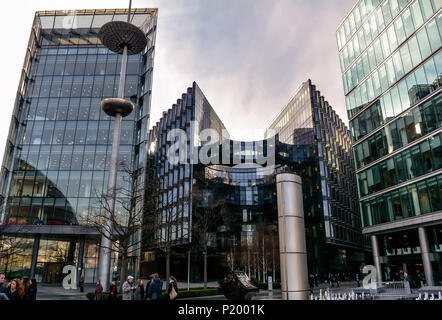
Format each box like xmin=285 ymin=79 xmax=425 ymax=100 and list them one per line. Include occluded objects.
xmin=0 ymin=9 xmax=157 ymax=283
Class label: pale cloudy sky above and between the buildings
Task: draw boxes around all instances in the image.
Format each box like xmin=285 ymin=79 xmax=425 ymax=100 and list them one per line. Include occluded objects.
xmin=0 ymin=0 xmax=356 ymax=159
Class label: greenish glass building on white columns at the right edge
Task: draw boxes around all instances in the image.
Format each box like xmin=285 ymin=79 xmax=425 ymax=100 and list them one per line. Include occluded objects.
xmin=337 ymin=0 xmax=442 ymax=286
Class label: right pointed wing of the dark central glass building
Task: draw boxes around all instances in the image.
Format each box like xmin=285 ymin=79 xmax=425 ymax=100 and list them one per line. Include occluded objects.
xmin=265 ymin=80 xmax=370 ymax=273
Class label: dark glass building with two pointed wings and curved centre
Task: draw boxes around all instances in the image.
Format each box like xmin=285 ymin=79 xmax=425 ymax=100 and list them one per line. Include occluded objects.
xmin=141 ymin=80 xmax=371 ymax=281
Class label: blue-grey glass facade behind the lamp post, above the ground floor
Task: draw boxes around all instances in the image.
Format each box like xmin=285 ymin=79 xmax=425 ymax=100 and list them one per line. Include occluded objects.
xmin=3 ymin=9 xmax=155 ymax=225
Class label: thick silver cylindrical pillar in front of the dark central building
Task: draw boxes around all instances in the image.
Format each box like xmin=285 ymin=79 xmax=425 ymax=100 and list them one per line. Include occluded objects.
xmin=276 ymin=173 xmax=309 ymax=300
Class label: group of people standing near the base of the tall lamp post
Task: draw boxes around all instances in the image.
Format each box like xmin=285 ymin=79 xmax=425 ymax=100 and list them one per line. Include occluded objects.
xmin=94 ymin=273 xmax=178 ymax=300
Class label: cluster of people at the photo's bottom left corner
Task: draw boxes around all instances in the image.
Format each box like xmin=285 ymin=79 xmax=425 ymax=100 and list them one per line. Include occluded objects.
xmin=0 ymin=273 xmax=37 ymax=301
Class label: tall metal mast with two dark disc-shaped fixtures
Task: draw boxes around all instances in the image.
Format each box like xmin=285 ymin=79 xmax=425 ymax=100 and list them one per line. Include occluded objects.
xmin=98 ymin=1 xmax=147 ymax=288
